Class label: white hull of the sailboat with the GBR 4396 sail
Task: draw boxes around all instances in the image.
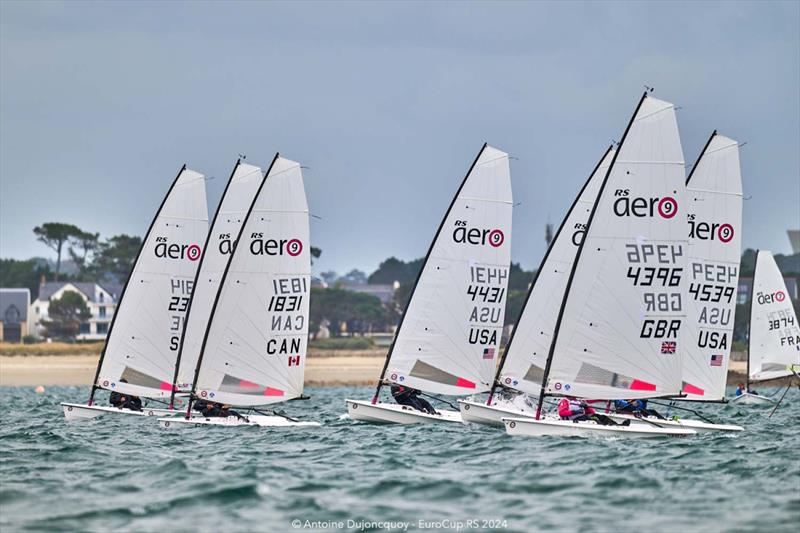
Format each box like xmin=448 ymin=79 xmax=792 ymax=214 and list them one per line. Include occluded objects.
xmin=503 ymin=418 xmax=697 ymax=439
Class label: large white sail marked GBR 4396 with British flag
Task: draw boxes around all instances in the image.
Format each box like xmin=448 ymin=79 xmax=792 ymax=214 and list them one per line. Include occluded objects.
xmin=547 ymin=96 xmax=687 ymax=399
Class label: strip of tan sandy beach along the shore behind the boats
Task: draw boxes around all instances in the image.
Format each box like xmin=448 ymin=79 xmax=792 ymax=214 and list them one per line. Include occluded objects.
xmin=0 ymin=350 xmax=746 ymax=387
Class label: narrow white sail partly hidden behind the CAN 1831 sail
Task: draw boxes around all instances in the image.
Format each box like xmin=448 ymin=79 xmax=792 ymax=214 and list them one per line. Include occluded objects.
xmin=176 ymin=162 xmax=263 ymax=390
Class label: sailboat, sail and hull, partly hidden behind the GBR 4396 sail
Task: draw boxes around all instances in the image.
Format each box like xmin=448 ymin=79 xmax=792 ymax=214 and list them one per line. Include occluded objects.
xmin=458 ymin=147 xmax=615 ymax=426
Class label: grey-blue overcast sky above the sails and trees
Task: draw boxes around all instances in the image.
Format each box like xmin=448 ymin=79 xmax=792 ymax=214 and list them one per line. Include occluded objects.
xmin=0 ymin=0 xmax=800 ymax=273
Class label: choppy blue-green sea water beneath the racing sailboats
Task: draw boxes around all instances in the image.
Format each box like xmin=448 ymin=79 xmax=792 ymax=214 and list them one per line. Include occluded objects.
xmin=0 ymin=388 xmax=800 ymax=533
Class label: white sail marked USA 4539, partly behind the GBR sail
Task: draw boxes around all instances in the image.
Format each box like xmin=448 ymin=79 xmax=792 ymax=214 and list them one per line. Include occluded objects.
xmin=681 ymin=132 xmax=742 ymax=401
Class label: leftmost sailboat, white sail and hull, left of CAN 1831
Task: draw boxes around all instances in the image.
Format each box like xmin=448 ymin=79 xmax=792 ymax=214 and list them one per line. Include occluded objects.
xmin=61 ymin=165 xmax=208 ymax=420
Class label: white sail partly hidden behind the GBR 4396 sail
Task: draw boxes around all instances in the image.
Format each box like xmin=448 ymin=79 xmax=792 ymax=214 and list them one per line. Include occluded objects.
xmin=500 ymin=148 xmax=614 ymax=394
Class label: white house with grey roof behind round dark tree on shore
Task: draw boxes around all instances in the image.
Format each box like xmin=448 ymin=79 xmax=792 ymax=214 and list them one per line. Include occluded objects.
xmin=31 ymin=281 xmax=122 ymax=340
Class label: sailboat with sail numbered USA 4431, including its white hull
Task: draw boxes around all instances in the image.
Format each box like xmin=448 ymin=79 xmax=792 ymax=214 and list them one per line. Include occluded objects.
xmin=346 ymin=144 xmax=513 ymax=424
